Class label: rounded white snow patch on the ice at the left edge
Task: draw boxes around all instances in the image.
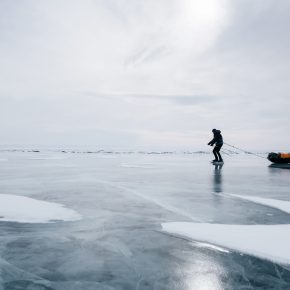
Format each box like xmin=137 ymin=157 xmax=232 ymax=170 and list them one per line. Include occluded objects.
xmin=0 ymin=194 xmax=81 ymax=223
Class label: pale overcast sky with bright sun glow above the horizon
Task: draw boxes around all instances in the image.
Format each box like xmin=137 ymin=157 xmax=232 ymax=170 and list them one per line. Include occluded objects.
xmin=0 ymin=0 xmax=290 ymax=151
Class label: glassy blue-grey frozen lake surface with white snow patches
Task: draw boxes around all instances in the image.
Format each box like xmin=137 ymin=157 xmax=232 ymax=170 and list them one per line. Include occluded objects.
xmin=0 ymin=152 xmax=290 ymax=290
